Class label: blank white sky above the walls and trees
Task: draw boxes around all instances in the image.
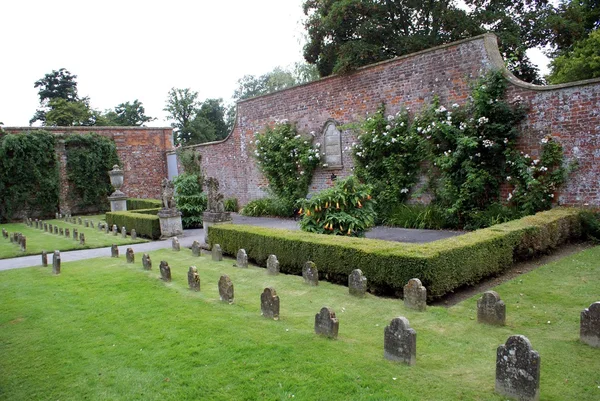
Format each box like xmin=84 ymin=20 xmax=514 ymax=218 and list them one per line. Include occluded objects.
xmin=0 ymin=0 xmax=548 ymax=127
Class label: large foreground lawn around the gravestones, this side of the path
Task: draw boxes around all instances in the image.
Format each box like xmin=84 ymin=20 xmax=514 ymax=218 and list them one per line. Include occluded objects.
xmin=0 ymin=244 xmax=600 ymax=401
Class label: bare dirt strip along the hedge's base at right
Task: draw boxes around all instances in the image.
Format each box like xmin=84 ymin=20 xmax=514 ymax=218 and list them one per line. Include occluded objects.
xmin=431 ymin=242 xmax=595 ymax=307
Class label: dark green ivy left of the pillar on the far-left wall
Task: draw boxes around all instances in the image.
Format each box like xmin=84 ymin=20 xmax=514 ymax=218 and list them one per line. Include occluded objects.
xmin=0 ymin=131 xmax=59 ymax=221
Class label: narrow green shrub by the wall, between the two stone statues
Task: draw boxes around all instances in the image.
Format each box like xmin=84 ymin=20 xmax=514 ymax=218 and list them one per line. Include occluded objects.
xmin=173 ymin=173 xmax=207 ymax=228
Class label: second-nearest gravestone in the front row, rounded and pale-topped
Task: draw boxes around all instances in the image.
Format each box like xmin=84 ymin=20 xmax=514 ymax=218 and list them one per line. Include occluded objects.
xmin=383 ymin=316 xmax=417 ymax=366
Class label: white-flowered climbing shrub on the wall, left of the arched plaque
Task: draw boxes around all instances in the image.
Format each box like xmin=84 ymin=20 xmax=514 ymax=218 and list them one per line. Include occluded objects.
xmin=254 ymin=122 xmax=321 ymax=208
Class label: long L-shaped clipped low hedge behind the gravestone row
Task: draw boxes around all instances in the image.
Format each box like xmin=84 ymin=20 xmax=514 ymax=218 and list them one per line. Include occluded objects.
xmin=208 ymin=208 xmax=582 ymax=299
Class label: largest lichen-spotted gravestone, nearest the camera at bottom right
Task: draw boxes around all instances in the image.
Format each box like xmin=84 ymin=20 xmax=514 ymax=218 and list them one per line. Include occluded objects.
xmin=496 ymin=336 xmax=540 ymax=401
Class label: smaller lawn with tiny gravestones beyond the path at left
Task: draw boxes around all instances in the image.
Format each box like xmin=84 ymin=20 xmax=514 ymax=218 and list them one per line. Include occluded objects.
xmin=0 ymin=215 xmax=147 ymax=259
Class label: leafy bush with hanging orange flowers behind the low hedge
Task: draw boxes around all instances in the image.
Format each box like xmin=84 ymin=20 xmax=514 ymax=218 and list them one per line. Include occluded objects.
xmin=299 ymin=176 xmax=375 ymax=237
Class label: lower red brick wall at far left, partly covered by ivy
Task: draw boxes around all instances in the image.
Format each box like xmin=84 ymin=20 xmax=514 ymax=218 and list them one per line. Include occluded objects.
xmin=4 ymin=127 xmax=173 ymax=212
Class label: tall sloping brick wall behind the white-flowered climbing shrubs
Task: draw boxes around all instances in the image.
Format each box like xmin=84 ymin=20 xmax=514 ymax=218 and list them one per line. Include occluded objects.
xmin=192 ymin=34 xmax=600 ymax=206
